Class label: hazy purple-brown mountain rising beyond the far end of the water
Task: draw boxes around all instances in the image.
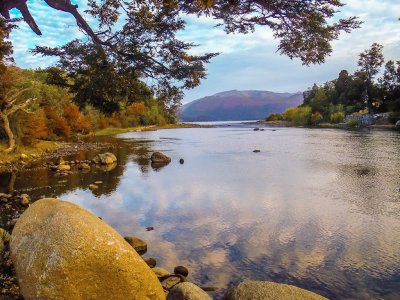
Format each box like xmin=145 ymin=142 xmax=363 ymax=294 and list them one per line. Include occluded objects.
xmin=179 ymin=90 xmax=303 ymax=122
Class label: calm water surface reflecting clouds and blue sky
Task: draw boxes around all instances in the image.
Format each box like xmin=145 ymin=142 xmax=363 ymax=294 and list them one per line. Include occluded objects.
xmin=0 ymin=126 xmax=400 ymax=299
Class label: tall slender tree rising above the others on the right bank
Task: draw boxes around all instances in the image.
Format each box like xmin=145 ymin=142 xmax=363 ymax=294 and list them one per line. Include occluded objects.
xmin=358 ymin=43 xmax=384 ymax=113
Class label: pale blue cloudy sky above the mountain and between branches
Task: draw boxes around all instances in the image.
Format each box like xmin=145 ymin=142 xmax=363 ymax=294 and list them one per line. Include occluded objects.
xmin=10 ymin=0 xmax=400 ymax=103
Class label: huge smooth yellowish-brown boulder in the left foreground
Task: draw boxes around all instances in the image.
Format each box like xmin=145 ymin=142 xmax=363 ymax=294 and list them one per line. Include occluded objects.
xmin=11 ymin=199 xmax=165 ymax=299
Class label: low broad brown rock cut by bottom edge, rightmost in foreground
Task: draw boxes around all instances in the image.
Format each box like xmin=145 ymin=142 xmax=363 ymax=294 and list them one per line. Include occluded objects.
xmin=224 ymin=280 xmax=326 ymax=300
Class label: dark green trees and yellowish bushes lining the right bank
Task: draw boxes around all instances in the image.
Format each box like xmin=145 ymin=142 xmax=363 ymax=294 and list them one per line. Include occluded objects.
xmin=266 ymin=43 xmax=400 ymax=126
